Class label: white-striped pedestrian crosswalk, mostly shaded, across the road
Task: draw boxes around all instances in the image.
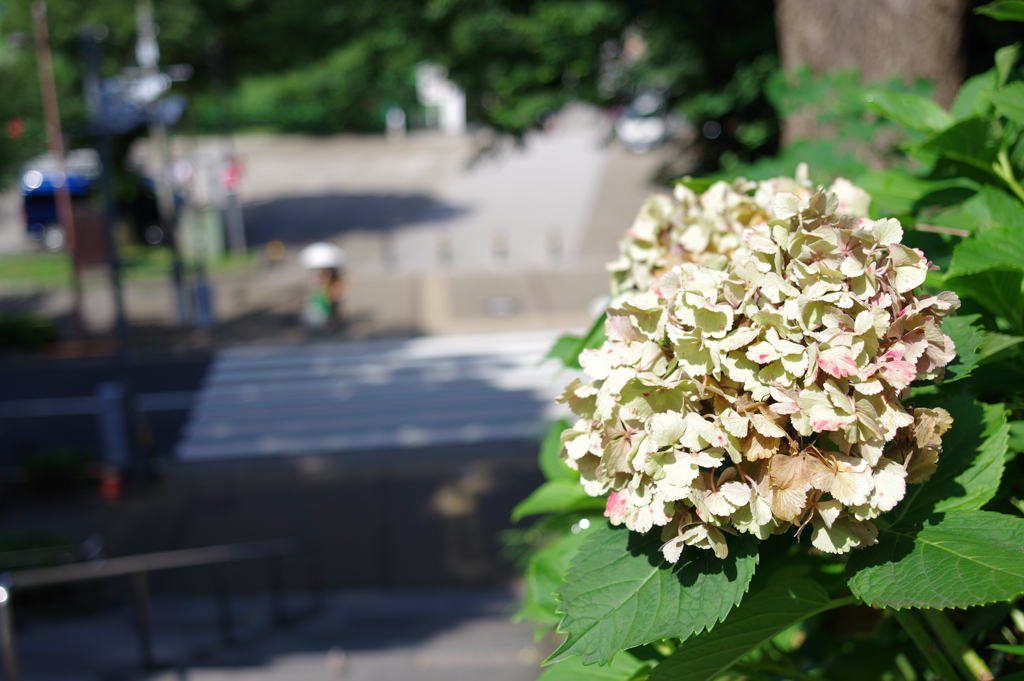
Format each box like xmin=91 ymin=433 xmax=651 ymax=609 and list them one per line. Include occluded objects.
xmin=177 ymin=332 xmax=585 ymax=462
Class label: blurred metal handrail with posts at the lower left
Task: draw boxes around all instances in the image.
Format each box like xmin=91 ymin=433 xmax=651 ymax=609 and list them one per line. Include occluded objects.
xmin=0 ymin=541 xmax=323 ymax=681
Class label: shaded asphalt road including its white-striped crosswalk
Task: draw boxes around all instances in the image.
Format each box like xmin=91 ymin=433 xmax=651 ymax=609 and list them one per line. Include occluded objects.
xmin=0 ymin=332 xmax=568 ymax=590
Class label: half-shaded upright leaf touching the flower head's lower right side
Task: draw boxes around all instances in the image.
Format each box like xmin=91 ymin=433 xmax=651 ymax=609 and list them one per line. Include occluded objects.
xmin=891 ymin=397 xmax=1010 ymax=524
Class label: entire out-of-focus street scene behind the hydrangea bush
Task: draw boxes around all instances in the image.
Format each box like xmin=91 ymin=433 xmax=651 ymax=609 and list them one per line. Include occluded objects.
xmin=0 ymin=0 xmax=1022 ymax=680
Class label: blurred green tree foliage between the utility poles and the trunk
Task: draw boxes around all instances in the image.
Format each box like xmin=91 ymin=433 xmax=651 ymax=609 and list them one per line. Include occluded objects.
xmin=192 ymin=0 xmax=777 ymax=167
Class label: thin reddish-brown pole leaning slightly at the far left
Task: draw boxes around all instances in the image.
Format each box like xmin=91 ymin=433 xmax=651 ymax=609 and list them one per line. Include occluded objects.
xmin=32 ymin=0 xmax=85 ymax=337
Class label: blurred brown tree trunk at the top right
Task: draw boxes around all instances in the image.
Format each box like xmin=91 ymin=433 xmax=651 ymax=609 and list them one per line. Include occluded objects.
xmin=775 ymin=0 xmax=969 ymax=143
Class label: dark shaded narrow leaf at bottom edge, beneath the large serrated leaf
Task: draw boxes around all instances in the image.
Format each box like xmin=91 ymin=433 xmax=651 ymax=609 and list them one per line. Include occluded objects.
xmin=650 ymin=580 xmax=842 ymax=681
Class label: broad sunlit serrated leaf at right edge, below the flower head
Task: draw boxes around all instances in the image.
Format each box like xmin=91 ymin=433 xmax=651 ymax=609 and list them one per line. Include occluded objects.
xmin=847 ymin=511 xmax=1024 ymax=609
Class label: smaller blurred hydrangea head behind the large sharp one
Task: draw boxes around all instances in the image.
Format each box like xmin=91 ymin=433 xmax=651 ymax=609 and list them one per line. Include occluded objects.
xmin=608 ymin=164 xmax=871 ymax=297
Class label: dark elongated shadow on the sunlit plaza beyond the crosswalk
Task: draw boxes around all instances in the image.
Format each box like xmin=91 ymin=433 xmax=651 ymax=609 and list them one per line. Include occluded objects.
xmin=243 ymin=194 xmax=466 ymax=246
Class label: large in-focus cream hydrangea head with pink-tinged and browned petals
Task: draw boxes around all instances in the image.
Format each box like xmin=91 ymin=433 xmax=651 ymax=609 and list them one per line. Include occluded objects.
xmin=560 ymin=183 xmax=959 ymax=562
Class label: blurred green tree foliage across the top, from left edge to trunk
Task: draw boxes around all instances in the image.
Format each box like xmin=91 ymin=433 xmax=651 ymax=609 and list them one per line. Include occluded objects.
xmin=0 ymin=0 xmax=777 ymax=180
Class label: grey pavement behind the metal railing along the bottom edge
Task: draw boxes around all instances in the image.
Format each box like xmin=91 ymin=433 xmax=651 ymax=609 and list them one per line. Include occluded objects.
xmin=9 ymin=590 xmax=551 ymax=681
